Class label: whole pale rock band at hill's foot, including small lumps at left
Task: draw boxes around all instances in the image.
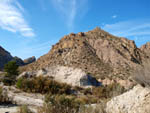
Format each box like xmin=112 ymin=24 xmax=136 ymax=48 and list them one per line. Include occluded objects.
xmin=19 ymin=65 xmax=101 ymax=87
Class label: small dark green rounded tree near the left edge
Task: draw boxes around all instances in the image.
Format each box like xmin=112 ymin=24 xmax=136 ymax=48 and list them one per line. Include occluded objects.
xmin=4 ymin=61 xmax=19 ymax=77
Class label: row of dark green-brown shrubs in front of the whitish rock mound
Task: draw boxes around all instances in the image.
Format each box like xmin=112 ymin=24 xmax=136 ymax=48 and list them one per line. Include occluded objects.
xmin=16 ymin=76 xmax=71 ymax=94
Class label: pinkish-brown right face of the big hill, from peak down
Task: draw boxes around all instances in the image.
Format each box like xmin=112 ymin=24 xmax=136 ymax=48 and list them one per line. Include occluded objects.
xmin=86 ymin=28 xmax=144 ymax=75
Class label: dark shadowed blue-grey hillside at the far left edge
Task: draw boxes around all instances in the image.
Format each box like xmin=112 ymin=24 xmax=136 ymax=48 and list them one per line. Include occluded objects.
xmin=0 ymin=46 xmax=13 ymax=69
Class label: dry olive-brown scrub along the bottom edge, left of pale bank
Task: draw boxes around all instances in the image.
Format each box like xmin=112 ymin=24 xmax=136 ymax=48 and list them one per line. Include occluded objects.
xmin=38 ymin=92 xmax=107 ymax=113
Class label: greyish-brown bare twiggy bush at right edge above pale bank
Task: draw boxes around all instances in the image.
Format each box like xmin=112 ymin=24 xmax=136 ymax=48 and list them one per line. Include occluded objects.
xmin=133 ymin=61 xmax=150 ymax=87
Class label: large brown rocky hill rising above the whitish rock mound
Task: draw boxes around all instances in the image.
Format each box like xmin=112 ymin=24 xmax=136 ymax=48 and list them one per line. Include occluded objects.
xmin=23 ymin=28 xmax=148 ymax=78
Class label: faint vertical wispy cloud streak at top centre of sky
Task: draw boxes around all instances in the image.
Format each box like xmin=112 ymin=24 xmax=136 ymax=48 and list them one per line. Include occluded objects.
xmin=52 ymin=0 xmax=88 ymax=28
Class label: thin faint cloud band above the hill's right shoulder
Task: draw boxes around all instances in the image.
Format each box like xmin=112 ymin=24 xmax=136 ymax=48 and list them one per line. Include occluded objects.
xmin=102 ymin=20 xmax=150 ymax=37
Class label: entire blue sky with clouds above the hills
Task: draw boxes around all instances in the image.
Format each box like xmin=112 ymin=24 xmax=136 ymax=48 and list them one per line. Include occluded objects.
xmin=0 ymin=0 xmax=150 ymax=59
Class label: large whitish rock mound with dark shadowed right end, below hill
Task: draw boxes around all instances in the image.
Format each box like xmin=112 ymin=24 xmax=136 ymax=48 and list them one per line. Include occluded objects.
xmin=44 ymin=66 xmax=101 ymax=87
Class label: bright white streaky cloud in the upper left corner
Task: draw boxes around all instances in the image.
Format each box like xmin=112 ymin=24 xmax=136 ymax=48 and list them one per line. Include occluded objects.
xmin=0 ymin=0 xmax=35 ymax=37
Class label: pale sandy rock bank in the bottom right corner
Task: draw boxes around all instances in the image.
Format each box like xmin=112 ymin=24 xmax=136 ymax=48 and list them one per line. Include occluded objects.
xmin=106 ymin=85 xmax=150 ymax=113
